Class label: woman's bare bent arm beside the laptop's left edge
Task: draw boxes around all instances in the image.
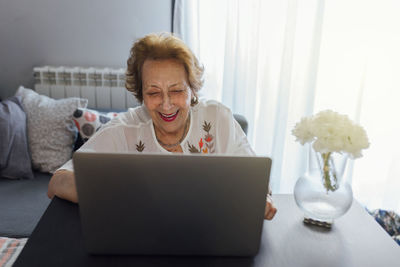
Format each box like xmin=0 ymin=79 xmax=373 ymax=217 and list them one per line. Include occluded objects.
xmin=47 ymin=170 xmax=78 ymax=203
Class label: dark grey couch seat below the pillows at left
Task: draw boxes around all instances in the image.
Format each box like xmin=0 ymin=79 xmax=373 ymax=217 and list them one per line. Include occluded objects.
xmin=0 ymin=172 xmax=51 ymax=238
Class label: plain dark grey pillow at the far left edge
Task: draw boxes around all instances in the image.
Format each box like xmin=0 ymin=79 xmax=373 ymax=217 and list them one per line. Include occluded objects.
xmin=0 ymin=96 xmax=33 ymax=179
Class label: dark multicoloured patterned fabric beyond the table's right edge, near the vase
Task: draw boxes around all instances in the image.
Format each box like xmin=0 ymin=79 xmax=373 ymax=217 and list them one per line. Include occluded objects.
xmin=368 ymin=209 xmax=400 ymax=245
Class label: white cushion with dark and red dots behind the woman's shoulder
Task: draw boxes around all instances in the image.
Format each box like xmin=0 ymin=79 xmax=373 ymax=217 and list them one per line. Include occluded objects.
xmin=73 ymin=108 xmax=118 ymax=142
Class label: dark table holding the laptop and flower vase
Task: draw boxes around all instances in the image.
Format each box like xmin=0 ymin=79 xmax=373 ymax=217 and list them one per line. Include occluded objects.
xmin=14 ymin=195 xmax=400 ymax=267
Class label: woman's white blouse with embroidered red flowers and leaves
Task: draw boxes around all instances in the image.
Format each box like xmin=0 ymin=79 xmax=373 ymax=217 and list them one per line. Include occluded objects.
xmin=59 ymin=100 xmax=255 ymax=171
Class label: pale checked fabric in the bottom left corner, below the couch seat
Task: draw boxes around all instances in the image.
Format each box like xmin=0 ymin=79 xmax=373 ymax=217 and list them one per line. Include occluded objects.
xmin=0 ymin=237 xmax=28 ymax=267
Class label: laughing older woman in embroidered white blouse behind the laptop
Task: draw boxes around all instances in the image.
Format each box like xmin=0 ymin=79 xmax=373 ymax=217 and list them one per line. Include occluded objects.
xmin=48 ymin=34 xmax=276 ymax=220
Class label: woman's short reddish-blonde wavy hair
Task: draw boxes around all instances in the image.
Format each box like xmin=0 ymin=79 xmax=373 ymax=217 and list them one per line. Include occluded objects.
xmin=125 ymin=33 xmax=204 ymax=105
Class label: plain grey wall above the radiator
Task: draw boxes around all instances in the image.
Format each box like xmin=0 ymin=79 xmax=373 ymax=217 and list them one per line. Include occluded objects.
xmin=0 ymin=0 xmax=172 ymax=99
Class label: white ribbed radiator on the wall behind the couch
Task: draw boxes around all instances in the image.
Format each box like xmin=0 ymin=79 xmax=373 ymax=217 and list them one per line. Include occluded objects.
xmin=33 ymin=66 xmax=139 ymax=110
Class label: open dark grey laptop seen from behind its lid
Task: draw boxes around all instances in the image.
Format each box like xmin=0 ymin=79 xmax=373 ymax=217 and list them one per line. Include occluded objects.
xmin=73 ymin=152 xmax=271 ymax=256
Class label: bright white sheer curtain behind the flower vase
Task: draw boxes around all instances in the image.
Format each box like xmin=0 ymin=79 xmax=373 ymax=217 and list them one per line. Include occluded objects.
xmin=174 ymin=0 xmax=400 ymax=212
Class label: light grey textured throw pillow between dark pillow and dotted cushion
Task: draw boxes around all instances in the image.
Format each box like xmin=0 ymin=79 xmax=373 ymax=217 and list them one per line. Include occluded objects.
xmin=16 ymin=86 xmax=87 ymax=173
